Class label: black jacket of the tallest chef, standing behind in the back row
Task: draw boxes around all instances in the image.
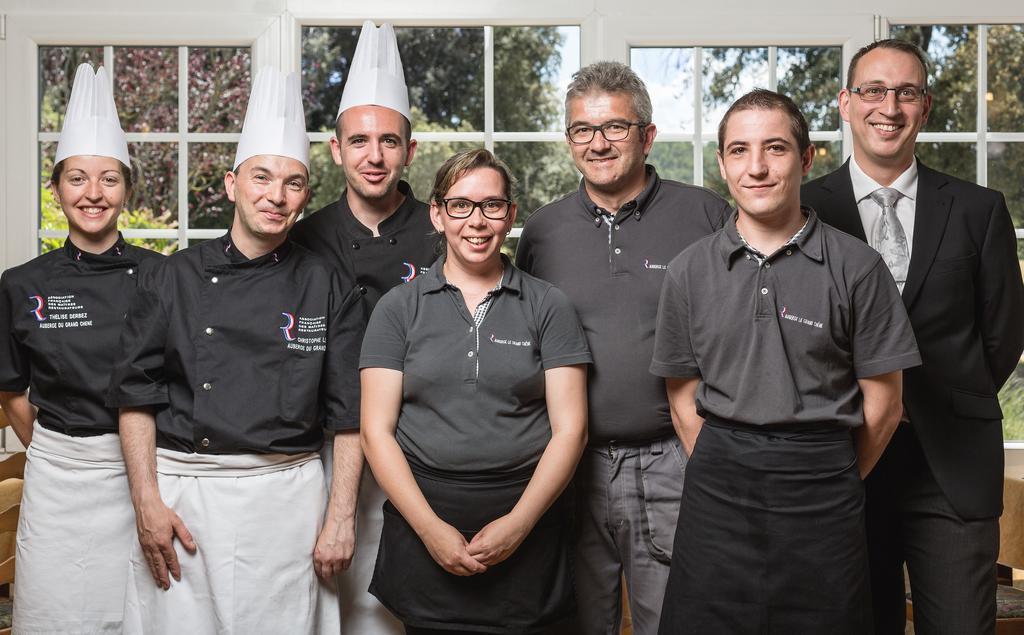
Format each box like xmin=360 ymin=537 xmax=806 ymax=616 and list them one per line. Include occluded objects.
xmin=291 ymin=181 xmax=440 ymax=308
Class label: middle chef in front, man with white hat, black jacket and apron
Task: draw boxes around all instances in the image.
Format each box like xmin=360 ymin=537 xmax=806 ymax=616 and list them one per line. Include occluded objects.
xmin=108 ymin=68 xmax=366 ymax=635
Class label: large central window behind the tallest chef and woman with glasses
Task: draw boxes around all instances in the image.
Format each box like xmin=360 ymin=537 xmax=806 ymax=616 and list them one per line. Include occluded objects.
xmin=302 ymin=26 xmax=580 ymax=249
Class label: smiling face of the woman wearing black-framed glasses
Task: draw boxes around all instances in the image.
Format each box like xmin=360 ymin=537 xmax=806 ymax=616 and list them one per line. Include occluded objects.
xmin=430 ymin=168 xmax=516 ymax=272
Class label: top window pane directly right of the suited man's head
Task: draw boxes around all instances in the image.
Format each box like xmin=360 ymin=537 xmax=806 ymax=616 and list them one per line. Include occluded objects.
xmin=890 ymin=25 xmax=978 ymax=133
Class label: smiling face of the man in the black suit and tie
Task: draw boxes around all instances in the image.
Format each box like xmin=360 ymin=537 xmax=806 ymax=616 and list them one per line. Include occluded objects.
xmin=839 ymin=47 xmax=932 ymax=174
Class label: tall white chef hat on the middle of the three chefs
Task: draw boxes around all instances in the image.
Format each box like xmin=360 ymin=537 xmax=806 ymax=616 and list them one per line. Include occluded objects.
xmin=232 ymin=67 xmax=309 ymax=170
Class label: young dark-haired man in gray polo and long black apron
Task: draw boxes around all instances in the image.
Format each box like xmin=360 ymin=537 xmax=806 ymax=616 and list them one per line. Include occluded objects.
xmin=650 ymin=90 xmax=921 ymax=635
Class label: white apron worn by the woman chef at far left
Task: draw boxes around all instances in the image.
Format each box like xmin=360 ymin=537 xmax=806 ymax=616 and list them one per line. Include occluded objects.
xmin=13 ymin=423 xmax=138 ymax=635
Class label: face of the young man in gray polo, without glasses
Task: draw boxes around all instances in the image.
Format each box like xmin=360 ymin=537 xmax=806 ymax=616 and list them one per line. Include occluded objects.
xmin=718 ymin=109 xmax=814 ymax=225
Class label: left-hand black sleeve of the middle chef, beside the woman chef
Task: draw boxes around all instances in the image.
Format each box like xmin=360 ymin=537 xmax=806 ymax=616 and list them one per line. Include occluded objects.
xmin=106 ymin=266 xmax=169 ymax=408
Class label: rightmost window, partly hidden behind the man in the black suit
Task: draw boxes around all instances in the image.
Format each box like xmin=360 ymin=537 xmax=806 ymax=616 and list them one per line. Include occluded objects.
xmin=889 ymin=25 xmax=1024 ymax=439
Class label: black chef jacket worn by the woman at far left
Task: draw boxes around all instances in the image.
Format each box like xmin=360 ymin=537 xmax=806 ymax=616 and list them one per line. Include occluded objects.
xmin=0 ymin=235 xmax=163 ymax=436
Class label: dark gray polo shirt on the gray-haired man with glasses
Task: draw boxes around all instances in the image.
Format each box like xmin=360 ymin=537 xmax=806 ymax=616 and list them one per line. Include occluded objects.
xmin=516 ymin=166 xmax=729 ymax=445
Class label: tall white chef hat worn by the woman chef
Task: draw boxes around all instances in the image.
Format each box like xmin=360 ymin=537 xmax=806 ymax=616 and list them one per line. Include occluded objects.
xmin=54 ymin=64 xmax=131 ymax=168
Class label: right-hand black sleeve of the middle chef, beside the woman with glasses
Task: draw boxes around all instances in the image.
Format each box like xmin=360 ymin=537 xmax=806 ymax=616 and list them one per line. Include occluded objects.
xmin=321 ymin=271 xmax=369 ymax=430
